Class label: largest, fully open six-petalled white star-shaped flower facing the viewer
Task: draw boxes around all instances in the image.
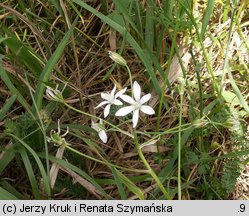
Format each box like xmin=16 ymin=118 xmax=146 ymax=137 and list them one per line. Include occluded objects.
xmin=115 ymin=81 xmax=155 ymax=128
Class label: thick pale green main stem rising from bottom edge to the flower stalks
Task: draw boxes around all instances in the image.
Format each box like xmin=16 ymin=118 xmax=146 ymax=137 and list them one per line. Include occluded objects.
xmin=134 ymin=131 xmax=171 ymax=200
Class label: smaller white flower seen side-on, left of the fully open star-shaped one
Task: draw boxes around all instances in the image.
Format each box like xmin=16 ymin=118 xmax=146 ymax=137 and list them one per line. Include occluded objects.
xmin=95 ymin=85 xmax=126 ymax=118
